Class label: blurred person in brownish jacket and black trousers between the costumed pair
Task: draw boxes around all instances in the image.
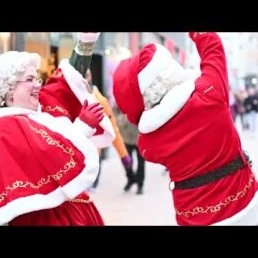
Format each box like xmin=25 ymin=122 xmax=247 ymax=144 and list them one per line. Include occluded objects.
xmin=113 ymin=106 xmax=145 ymax=194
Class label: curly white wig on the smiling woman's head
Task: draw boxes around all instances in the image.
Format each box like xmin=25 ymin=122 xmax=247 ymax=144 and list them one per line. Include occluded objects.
xmin=0 ymin=51 xmax=41 ymax=106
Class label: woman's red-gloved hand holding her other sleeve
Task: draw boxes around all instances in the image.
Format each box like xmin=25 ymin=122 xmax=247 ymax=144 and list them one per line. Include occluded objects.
xmin=79 ymin=100 xmax=104 ymax=128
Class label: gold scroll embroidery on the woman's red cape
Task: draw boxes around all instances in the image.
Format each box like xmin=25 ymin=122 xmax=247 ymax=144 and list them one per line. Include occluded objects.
xmin=0 ymin=125 xmax=77 ymax=204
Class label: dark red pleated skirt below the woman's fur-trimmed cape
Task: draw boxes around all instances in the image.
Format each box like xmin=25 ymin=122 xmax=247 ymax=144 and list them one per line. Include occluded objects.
xmin=9 ymin=191 xmax=104 ymax=226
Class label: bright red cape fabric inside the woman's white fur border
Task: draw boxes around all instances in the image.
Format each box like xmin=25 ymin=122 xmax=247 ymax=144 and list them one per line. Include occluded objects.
xmin=0 ymin=116 xmax=85 ymax=207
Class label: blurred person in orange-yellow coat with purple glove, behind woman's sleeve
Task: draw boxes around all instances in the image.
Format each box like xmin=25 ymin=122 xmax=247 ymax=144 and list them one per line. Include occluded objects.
xmin=85 ymin=69 xmax=132 ymax=190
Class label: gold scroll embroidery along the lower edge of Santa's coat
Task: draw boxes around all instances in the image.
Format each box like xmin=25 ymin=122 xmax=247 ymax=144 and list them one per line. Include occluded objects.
xmin=176 ymin=174 xmax=254 ymax=218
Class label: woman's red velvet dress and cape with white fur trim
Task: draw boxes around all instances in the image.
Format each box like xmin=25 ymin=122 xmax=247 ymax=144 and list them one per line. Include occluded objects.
xmin=0 ymin=61 xmax=114 ymax=226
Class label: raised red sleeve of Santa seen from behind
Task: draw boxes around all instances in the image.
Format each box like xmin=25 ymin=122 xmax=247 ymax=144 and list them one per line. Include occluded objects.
xmin=189 ymin=32 xmax=229 ymax=102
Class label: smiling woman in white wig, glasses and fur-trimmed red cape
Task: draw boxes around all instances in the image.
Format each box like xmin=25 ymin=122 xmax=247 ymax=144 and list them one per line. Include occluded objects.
xmin=0 ymin=33 xmax=114 ymax=226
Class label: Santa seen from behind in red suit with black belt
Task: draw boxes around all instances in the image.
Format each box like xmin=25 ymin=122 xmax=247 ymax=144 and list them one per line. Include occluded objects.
xmin=113 ymin=32 xmax=258 ymax=226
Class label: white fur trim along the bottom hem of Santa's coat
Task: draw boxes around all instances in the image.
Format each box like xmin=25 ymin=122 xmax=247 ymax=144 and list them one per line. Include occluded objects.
xmin=212 ymin=192 xmax=258 ymax=226
